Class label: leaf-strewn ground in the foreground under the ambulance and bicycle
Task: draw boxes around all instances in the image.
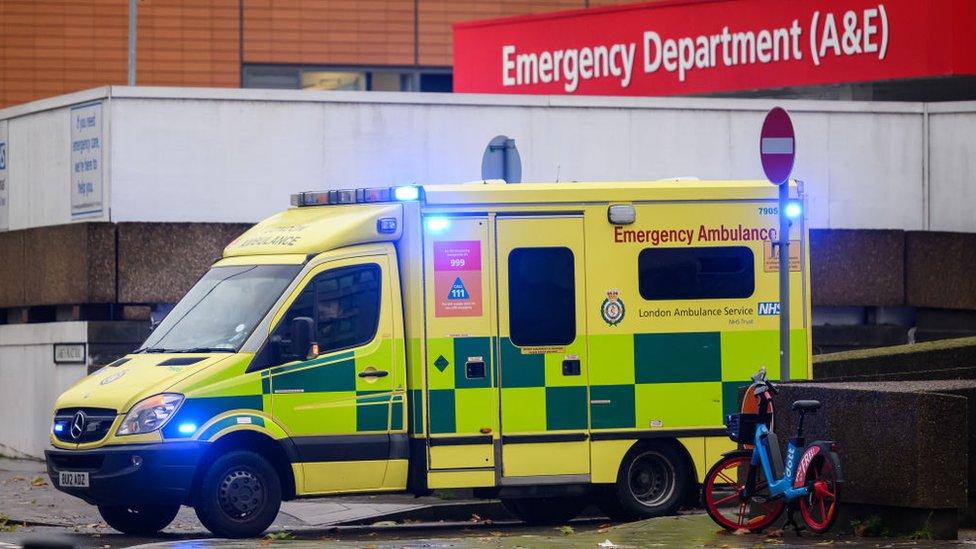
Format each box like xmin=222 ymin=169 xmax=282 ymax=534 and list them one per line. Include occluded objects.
xmin=0 ymin=459 xmax=976 ymax=549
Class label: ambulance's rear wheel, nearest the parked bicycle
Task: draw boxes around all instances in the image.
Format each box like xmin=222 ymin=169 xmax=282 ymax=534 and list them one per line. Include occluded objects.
xmin=597 ymin=444 xmax=690 ymax=521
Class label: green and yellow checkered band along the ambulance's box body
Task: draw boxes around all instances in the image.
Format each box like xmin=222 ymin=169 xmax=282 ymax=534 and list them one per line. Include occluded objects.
xmin=424 ymin=330 xmax=807 ymax=434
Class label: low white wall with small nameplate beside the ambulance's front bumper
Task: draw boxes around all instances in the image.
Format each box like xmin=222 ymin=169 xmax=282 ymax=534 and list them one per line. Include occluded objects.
xmin=0 ymin=322 xmax=88 ymax=459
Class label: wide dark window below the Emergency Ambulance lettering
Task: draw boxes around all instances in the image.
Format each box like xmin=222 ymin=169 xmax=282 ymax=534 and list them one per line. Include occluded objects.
xmin=637 ymin=246 xmax=756 ymax=300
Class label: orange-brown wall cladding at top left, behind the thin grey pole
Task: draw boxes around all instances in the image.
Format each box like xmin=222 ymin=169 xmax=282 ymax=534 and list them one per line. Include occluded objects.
xmin=0 ymin=0 xmax=240 ymax=107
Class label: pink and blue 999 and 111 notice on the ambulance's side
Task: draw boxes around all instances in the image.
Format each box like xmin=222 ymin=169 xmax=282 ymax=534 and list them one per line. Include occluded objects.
xmin=434 ymin=240 xmax=481 ymax=316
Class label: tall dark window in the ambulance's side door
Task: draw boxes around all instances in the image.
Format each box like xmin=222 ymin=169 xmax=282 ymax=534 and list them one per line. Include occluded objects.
xmin=508 ymin=248 xmax=576 ymax=346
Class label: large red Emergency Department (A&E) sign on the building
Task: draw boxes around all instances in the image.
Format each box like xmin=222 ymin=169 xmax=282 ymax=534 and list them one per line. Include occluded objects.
xmin=454 ymin=0 xmax=976 ymax=95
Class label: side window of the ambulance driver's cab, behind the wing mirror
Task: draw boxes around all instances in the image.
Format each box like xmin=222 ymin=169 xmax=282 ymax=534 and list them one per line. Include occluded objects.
xmin=278 ymin=264 xmax=380 ymax=353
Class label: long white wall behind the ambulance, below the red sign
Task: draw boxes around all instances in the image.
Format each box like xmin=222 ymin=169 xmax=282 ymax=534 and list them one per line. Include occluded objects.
xmin=0 ymin=87 xmax=976 ymax=232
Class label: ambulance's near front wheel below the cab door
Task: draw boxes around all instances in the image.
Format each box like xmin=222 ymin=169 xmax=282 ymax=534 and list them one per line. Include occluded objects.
xmin=195 ymin=450 xmax=281 ymax=538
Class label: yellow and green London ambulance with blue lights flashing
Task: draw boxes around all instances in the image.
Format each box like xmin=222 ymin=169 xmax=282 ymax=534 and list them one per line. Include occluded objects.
xmin=47 ymin=180 xmax=811 ymax=537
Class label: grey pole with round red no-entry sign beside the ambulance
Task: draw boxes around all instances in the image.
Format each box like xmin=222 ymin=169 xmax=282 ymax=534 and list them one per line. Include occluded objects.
xmin=759 ymin=107 xmax=802 ymax=381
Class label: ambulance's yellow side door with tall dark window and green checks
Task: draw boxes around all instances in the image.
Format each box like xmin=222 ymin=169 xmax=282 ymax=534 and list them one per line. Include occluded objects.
xmin=495 ymin=214 xmax=590 ymax=484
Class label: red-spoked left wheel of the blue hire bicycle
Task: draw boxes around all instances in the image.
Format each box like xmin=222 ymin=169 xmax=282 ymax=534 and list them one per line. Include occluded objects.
xmin=702 ymin=453 xmax=785 ymax=532
